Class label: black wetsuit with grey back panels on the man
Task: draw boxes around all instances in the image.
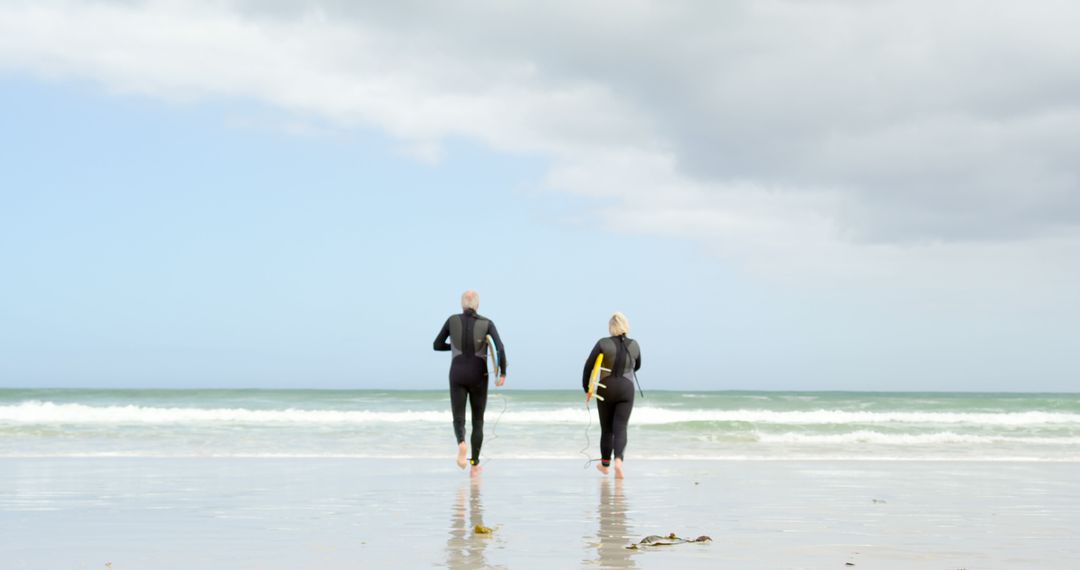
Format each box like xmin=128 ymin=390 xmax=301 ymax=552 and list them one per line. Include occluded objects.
xmin=434 ymin=309 xmax=507 ymax=465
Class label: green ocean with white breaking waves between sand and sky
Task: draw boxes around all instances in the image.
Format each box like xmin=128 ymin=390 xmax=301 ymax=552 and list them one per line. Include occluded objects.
xmin=0 ymin=386 xmax=1080 ymax=462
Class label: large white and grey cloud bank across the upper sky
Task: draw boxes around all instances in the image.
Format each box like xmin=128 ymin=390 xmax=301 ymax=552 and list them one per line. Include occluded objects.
xmin=0 ymin=0 xmax=1080 ymax=285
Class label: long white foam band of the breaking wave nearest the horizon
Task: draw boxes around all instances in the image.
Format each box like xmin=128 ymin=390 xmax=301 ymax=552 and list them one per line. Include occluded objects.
xmin=0 ymin=402 xmax=1080 ymax=428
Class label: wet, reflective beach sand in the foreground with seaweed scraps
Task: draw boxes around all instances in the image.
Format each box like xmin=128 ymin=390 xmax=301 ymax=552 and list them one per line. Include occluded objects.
xmin=0 ymin=456 xmax=1080 ymax=570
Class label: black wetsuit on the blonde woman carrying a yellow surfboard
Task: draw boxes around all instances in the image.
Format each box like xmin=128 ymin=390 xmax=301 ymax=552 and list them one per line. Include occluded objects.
xmin=581 ymin=336 xmax=642 ymax=465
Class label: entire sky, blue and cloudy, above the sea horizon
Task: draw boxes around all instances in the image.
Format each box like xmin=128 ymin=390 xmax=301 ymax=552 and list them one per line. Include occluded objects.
xmin=0 ymin=0 xmax=1080 ymax=392
